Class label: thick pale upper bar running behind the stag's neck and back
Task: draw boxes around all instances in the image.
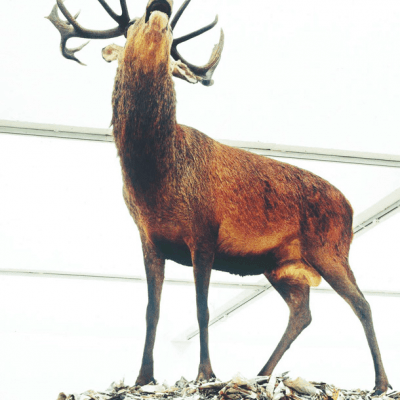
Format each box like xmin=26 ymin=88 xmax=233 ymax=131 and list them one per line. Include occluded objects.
xmin=0 ymin=120 xmax=400 ymax=168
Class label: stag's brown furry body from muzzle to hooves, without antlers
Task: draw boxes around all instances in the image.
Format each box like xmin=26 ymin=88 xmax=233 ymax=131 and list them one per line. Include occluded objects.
xmin=108 ymin=2 xmax=388 ymax=391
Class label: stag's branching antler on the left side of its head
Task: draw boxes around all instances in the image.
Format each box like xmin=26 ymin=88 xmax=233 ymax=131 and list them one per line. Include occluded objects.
xmin=46 ymin=0 xmax=129 ymax=65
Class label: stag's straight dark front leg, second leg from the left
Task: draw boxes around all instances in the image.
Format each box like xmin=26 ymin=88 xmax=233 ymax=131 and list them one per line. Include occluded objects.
xmin=192 ymin=251 xmax=215 ymax=381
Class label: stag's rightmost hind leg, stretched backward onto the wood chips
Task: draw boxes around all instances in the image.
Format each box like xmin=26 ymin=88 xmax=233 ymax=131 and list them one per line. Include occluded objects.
xmin=316 ymin=261 xmax=390 ymax=394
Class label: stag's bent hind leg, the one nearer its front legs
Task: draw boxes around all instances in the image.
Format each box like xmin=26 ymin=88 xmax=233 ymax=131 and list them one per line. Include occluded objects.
xmin=258 ymin=273 xmax=311 ymax=376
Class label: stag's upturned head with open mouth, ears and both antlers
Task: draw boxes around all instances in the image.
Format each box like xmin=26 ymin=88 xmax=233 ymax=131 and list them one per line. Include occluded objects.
xmin=46 ymin=0 xmax=224 ymax=86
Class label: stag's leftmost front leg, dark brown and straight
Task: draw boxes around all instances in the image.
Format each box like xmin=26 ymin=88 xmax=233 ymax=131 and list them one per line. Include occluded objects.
xmin=136 ymin=244 xmax=165 ymax=386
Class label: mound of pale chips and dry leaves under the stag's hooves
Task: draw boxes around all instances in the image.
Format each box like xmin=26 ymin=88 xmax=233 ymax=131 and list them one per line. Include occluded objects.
xmin=57 ymin=373 xmax=400 ymax=400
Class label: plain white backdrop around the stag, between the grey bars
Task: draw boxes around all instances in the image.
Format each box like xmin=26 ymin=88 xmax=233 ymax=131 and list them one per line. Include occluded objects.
xmin=0 ymin=0 xmax=400 ymax=400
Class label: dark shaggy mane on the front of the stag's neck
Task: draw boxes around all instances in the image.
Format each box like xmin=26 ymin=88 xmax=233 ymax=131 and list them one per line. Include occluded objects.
xmin=112 ymin=59 xmax=176 ymax=195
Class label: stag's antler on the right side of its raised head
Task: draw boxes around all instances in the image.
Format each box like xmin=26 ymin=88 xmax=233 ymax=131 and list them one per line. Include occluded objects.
xmin=171 ymin=0 xmax=224 ymax=86
